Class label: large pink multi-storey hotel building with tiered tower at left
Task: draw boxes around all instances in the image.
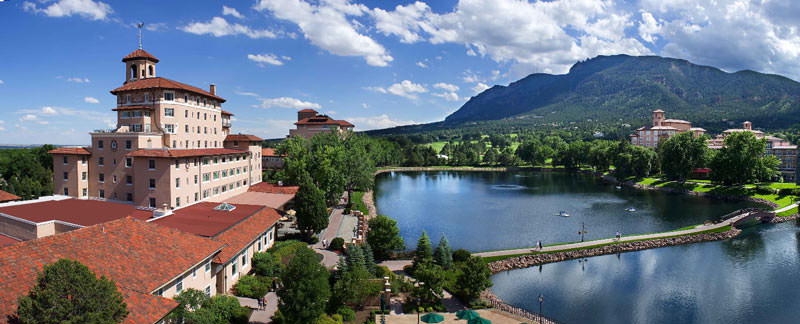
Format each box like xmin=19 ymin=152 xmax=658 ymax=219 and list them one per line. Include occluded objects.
xmin=50 ymin=49 xmax=262 ymax=208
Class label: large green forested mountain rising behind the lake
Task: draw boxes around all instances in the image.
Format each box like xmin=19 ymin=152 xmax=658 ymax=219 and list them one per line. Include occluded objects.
xmin=444 ymin=55 xmax=800 ymax=130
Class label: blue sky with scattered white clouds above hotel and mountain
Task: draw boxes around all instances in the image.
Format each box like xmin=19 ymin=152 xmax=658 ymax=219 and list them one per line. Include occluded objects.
xmin=0 ymin=0 xmax=800 ymax=145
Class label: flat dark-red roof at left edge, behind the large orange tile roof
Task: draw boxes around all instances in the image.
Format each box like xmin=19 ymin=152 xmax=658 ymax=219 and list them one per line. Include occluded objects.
xmin=0 ymin=199 xmax=153 ymax=226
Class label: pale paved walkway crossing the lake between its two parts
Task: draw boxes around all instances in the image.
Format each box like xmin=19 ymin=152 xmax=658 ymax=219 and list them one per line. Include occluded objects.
xmin=472 ymin=213 xmax=749 ymax=258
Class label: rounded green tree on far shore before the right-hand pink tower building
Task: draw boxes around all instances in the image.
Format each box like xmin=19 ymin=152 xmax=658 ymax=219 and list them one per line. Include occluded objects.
xmin=658 ymin=132 xmax=708 ymax=181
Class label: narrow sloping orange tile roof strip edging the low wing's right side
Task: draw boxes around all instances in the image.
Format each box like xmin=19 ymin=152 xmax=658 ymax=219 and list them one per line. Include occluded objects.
xmin=214 ymin=207 xmax=281 ymax=263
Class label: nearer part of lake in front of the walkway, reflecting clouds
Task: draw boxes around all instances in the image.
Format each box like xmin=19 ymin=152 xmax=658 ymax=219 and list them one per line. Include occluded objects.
xmin=491 ymin=221 xmax=800 ymax=324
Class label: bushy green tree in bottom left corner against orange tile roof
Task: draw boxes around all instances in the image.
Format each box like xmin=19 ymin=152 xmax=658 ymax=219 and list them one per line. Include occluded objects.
xmin=17 ymin=259 xmax=128 ymax=324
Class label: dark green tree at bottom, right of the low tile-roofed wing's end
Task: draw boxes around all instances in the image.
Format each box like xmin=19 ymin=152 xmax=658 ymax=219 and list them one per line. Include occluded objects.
xmin=277 ymin=247 xmax=331 ymax=324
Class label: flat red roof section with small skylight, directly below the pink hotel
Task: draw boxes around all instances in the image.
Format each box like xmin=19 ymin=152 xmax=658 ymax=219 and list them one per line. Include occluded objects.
xmin=152 ymin=202 xmax=264 ymax=237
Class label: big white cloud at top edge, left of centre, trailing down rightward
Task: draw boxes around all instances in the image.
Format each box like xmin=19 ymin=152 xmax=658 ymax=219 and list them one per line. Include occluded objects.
xmin=254 ymin=0 xmax=393 ymax=66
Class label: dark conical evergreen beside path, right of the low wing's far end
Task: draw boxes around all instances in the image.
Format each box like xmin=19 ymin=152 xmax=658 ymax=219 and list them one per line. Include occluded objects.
xmin=294 ymin=175 xmax=328 ymax=238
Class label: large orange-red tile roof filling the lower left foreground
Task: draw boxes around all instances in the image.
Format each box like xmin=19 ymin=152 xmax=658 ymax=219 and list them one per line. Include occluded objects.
xmin=0 ymin=217 xmax=224 ymax=323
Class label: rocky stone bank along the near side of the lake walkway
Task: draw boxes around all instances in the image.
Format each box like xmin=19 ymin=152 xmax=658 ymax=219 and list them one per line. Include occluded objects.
xmin=489 ymin=228 xmax=742 ymax=274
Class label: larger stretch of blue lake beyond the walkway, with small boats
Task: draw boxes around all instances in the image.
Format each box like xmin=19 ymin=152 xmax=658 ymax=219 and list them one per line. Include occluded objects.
xmin=375 ymin=171 xmax=761 ymax=252
